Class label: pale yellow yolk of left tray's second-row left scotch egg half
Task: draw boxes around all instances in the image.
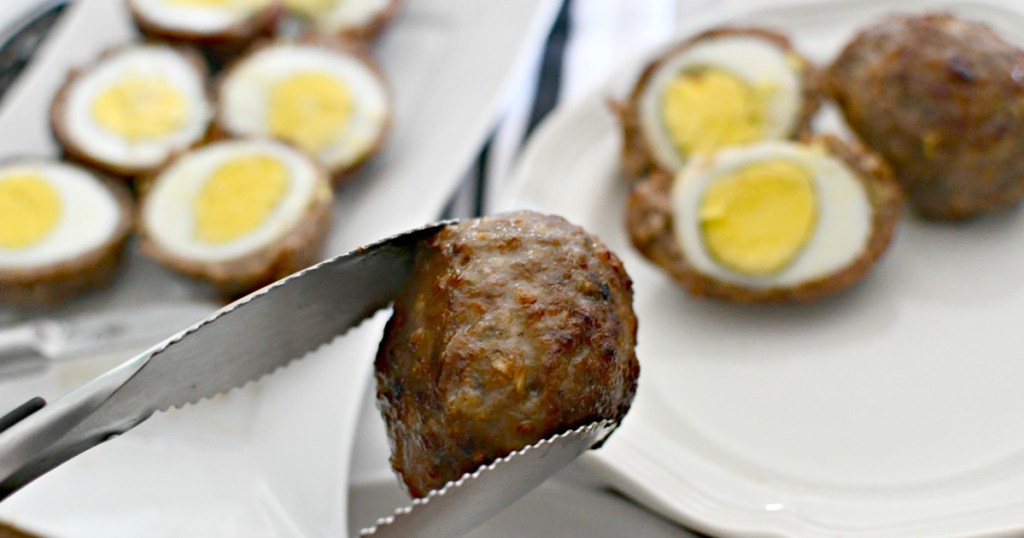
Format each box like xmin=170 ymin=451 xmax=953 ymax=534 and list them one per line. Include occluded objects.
xmin=92 ymin=75 xmax=188 ymax=140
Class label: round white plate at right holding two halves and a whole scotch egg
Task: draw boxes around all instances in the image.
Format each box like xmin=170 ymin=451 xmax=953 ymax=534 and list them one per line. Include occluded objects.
xmin=501 ymin=0 xmax=1024 ymax=536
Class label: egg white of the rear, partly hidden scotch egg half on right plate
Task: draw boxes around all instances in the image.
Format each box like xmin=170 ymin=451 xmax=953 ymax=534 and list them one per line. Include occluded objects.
xmin=639 ymin=35 xmax=803 ymax=170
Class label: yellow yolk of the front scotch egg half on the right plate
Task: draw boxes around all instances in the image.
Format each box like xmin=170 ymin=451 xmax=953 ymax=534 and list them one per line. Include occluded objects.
xmin=699 ymin=161 xmax=818 ymax=276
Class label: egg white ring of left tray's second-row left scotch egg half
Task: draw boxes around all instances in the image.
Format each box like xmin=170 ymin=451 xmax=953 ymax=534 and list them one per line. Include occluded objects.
xmin=57 ymin=45 xmax=213 ymax=172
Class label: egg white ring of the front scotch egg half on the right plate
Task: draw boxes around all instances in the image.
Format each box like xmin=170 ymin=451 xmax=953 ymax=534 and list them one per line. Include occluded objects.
xmin=672 ymin=140 xmax=872 ymax=289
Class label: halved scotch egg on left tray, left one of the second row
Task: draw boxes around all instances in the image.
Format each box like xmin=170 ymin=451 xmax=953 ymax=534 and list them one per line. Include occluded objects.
xmin=50 ymin=45 xmax=213 ymax=176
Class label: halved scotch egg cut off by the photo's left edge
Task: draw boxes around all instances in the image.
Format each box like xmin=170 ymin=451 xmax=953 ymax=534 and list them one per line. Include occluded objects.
xmin=0 ymin=158 xmax=133 ymax=306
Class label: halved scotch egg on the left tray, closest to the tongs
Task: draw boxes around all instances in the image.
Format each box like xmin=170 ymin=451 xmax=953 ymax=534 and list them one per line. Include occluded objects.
xmin=140 ymin=139 xmax=333 ymax=297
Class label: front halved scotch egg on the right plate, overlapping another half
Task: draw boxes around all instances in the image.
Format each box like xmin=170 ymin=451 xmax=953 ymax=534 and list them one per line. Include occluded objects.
xmin=627 ymin=136 xmax=902 ymax=302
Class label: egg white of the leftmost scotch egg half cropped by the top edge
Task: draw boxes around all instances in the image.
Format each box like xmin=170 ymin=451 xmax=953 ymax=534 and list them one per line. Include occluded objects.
xmin=128 ymin=0 xmax=271 ymax=35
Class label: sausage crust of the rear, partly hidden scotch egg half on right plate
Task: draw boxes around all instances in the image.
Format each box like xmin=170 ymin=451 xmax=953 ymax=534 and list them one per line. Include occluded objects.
xmin=608 ymin=28 xmax=821 ymax=180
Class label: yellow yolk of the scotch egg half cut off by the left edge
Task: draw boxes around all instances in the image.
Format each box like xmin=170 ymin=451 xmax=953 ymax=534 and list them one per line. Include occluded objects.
xmin=0 ymin=174 xmax=61 ymax=249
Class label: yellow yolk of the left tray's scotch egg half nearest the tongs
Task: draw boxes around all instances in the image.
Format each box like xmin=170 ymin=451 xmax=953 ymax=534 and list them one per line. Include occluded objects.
xmin=195 ymin=156 xmax=289 ymax=243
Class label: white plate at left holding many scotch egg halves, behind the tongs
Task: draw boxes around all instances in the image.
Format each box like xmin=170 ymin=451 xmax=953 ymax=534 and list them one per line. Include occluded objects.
xmin=0 ymin=0 xmax=557 ymax=538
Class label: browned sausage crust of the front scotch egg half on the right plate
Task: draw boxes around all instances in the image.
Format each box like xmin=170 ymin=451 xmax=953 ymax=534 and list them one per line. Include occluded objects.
xmin=626 ymin=135 xmax=903 ymax=302
